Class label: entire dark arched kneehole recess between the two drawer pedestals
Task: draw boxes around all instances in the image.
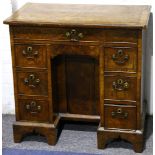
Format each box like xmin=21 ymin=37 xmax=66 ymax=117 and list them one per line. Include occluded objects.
xmin=52 ymin=55 xmax=99 ymax=115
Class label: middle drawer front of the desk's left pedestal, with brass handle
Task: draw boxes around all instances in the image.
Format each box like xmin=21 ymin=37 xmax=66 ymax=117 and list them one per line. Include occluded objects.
xmin=16 ymin=71 xmax=48 ymax=96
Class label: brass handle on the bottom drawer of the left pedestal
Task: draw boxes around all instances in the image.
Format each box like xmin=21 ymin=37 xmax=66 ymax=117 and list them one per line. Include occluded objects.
xmin=25 ymin=101 xmax=41 ymax=113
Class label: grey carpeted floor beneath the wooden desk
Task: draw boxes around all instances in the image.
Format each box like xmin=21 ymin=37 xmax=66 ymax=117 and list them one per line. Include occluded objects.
xmin=2 ymin=115 xmax=153 ymax=155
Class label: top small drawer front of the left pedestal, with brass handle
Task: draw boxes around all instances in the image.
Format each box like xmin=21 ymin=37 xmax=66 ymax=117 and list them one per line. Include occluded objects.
xmin=15 ymin=44 xmax=46 ymax=68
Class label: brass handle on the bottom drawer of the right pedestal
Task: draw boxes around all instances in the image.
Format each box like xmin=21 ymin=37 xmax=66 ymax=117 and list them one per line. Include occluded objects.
xmin=111 ymin=108 xmax=128 ymax=119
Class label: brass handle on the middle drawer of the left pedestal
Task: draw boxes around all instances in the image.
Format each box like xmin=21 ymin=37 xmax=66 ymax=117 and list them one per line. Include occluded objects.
xmin=24 ymin=74 xmax=40 ymax=88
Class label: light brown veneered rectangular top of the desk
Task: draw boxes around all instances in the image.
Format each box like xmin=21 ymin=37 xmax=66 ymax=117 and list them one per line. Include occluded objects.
xmin=4 ymin=3 xmax=151 ymax=28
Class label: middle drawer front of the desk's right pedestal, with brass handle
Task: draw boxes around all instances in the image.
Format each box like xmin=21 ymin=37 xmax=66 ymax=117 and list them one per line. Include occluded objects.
xmin=104 ymin=75 xmax=137 ymax=101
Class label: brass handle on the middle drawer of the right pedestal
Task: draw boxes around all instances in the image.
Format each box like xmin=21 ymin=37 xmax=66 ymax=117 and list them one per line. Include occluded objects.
xmin=112 ymin=79 xmax=129 ymax=91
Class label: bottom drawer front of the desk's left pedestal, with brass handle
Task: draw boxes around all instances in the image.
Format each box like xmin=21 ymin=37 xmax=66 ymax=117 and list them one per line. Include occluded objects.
xmin=18 ymin=99 xmax=49 ymax=122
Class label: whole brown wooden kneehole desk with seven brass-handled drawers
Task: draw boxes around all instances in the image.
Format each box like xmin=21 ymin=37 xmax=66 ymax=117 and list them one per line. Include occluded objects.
xmin=4 ymin=3 xmax=150 ymax=152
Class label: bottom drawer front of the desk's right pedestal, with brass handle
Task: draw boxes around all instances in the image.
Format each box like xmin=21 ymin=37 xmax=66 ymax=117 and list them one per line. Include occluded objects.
xmin=104 ymin=105 xmax=136 ymax=129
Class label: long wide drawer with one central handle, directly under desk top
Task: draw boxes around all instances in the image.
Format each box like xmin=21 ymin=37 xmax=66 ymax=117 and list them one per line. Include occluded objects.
xmin=13 ymin=26 xmax=137 ymax=43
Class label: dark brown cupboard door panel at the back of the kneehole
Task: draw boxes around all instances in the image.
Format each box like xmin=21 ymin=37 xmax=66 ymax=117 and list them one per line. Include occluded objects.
xmin=66 ymin=56 xmax=99 ymax=115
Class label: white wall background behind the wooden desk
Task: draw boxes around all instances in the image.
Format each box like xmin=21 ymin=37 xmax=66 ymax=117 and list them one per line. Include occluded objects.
xmin=0 ymin=0 xmax=154 ymax=114
